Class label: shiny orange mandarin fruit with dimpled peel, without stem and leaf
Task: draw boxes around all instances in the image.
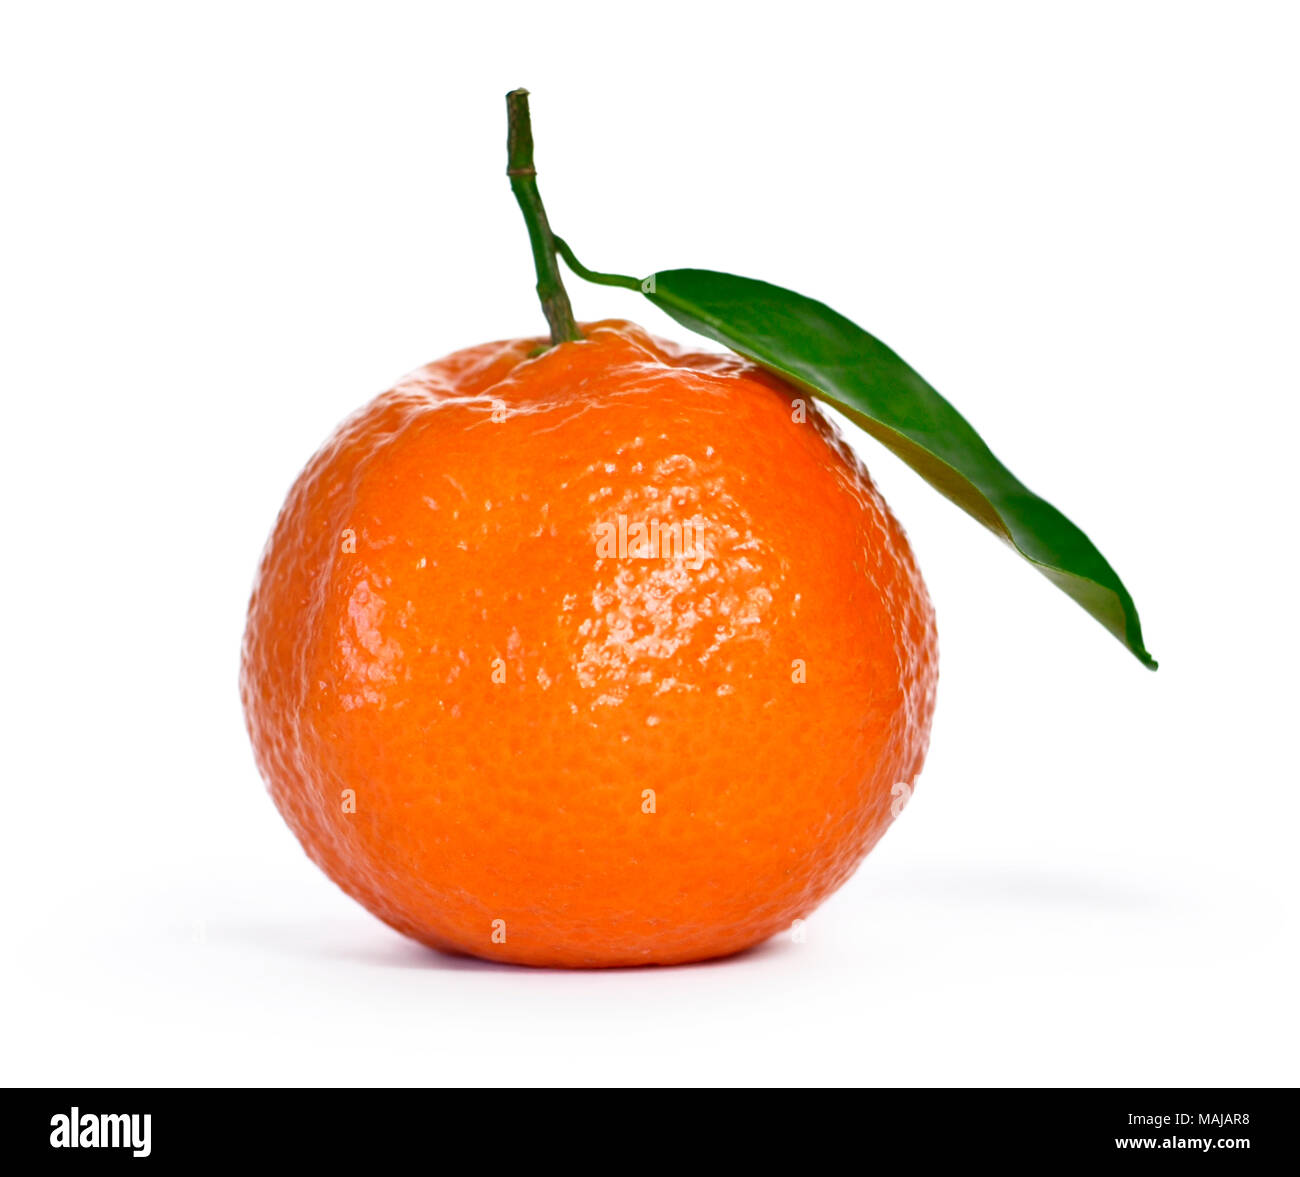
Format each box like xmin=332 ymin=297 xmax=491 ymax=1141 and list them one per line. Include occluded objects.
xmin=242 ymin=321 xmax=937 ymax=968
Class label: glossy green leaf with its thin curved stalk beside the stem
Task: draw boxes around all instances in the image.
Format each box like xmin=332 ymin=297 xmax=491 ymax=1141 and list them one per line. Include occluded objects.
xmin=556 ymin=239 xmax=1156 ymax=670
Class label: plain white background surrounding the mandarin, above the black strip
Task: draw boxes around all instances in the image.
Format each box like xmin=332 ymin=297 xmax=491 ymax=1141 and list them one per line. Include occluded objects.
xmin=0 ymin=0 xmax=1300 ymax=1085
